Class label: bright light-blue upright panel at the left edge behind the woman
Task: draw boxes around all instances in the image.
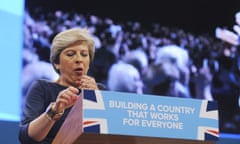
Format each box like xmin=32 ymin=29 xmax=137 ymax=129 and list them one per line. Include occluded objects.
xmin=0 ymin=0 xmax=24 ymax=121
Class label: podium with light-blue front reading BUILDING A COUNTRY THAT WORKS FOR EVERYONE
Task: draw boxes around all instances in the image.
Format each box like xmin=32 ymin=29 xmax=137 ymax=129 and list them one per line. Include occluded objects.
xmin=53 ymin=90 xmax=219 ymax=144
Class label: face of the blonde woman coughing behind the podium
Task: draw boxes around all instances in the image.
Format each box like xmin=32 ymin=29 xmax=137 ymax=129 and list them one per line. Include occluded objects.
xmin=55 ymin=41 xmax=90 ymax=87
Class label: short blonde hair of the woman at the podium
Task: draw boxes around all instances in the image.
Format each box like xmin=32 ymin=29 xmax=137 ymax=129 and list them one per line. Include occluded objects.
xmin=50 ymin=28 xmax=95 ymax=73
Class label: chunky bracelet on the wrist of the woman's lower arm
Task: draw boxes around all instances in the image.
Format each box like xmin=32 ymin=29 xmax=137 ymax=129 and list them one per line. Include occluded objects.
xmin=45 ymin=103 xmax=64 ymax=121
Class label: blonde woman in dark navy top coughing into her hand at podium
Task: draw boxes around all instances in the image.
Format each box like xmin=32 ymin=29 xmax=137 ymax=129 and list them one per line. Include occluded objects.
xmin=19 ymin=28 xmax=98 ymax=144
